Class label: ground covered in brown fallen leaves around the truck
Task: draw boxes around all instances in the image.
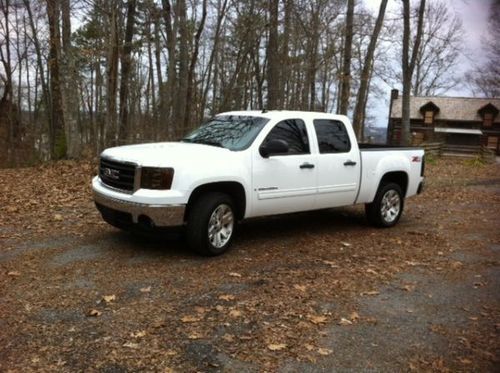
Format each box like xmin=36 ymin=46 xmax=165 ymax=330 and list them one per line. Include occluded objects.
xmin=0 ymin=160 xmax=500 ymax=372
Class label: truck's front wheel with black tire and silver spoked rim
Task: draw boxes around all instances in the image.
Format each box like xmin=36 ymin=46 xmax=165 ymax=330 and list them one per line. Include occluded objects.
xmin=186 ymin=192 xmax=236 ymax=256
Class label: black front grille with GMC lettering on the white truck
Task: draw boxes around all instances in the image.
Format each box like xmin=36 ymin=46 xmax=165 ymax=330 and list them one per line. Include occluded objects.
xmin=99 ymin=158 xmax=135 ymax=192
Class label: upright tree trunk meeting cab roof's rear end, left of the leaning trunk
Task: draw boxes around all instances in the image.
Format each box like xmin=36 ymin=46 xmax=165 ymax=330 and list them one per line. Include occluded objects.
xmin=339 ymin=0 xmax=355 ymax=115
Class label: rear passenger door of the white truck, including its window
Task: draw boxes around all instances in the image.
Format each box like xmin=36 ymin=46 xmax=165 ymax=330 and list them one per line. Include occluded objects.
xmin=313 ymin=119 xmax=361 ymax=209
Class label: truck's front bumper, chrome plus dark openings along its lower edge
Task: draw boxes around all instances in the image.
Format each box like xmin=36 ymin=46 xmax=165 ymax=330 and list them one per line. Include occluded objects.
xmin=94 ymin=190 xmax=186 ymax=227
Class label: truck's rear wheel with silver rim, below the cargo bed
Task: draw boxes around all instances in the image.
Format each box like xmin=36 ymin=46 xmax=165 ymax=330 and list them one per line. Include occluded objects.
xmin=365 ymin=183 xmax=404 ymax=228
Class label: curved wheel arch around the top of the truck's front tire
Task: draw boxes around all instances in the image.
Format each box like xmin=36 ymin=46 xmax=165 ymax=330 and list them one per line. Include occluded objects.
xmin=184 ymin=181 xmax=246 ymax=221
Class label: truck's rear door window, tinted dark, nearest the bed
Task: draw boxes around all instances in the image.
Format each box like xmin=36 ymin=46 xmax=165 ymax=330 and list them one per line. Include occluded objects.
xmin=314 ymin=119 xmax=351 ymax=154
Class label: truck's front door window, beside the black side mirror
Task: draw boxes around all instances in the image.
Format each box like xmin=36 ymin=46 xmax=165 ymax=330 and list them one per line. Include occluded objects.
xmin=264 ymin=119 xmax=309 ymax=154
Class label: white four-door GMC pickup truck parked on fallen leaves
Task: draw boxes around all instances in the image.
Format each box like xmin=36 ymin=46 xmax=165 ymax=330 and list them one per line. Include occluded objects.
xmin=92 ymin=111 xmax=424 ymax=255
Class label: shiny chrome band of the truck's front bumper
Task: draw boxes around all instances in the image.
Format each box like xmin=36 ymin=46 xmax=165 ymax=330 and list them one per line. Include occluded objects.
xmin=94 ymin=190 xmax=186 ymax=227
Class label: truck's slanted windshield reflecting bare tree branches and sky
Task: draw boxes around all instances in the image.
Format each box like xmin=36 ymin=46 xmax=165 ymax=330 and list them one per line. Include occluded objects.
xmin=181 ymin=115 xmax=269 ymax=150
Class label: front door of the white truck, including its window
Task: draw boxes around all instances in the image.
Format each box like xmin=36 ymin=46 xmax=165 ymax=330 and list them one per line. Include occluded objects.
xmin=252 ymin=119 xmax=317 ymax=216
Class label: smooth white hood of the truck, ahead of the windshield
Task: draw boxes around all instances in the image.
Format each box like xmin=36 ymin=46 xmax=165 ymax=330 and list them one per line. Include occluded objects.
xmin=101 ymin=142 xmax=234 ymax=167
